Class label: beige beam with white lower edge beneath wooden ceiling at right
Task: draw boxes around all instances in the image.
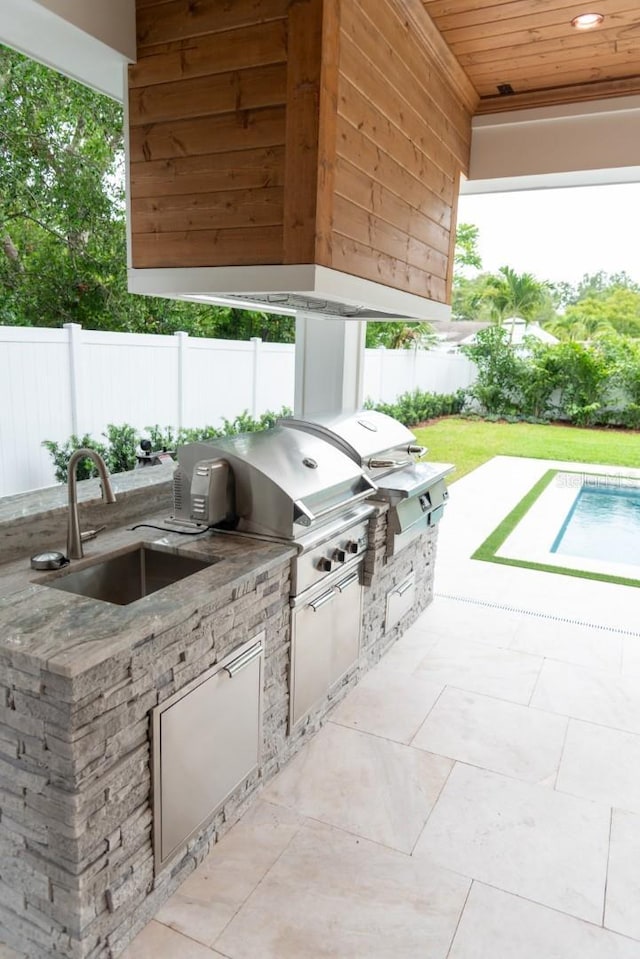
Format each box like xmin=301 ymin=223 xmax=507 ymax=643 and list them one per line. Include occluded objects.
xmin=461 ymin=96 xmax=640 ymax=194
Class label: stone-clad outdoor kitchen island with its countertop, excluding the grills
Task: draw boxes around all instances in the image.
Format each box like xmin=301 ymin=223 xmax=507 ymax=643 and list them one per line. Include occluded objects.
xmin=0 ymin=464 xmax=437 ymax=959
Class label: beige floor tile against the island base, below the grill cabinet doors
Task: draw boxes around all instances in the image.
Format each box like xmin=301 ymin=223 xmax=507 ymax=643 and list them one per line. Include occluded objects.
xmin=263 ymin=723 xmax=453 ymax=852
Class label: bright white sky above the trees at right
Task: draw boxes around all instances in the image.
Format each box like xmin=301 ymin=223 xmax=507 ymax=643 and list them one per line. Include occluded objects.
xmin=458 ymin=183 xmax=640 ymax=285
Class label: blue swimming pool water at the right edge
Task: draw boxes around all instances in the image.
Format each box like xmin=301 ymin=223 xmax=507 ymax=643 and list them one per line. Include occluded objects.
xmin=551 ymin=486 xmax=640 ymax=566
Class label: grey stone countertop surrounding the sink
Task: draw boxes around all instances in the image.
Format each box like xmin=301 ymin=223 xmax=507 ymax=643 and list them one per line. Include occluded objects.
xmin=0 ymin=513 xmax=296 ymax=679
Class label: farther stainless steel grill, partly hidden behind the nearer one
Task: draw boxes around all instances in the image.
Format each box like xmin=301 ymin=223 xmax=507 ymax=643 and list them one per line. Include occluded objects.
xmin=280 ymin=410 xmax=454 ymax=555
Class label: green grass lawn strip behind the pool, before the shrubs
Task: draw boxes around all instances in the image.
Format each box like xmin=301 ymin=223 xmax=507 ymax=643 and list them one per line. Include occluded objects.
xmin=413 ymin=416 xmax=640 ymax=481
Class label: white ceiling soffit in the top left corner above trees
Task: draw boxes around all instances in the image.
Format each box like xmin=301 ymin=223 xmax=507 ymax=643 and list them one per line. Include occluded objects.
xmin=0 ymin=0 xmax=135 ymax=101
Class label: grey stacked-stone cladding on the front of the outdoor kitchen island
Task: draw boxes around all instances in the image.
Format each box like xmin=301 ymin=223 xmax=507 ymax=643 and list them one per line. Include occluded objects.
xmin=0 ymin=506 xmax=436 ymax=959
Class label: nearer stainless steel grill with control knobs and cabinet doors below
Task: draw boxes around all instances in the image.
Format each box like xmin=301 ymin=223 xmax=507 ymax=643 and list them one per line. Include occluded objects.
xmin=173 ymin=426 xmax=376 ymax=727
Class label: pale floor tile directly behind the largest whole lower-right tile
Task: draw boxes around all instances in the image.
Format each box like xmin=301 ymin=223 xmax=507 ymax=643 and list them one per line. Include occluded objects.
xmin=411 ymin=687 xmax=568 ymax=785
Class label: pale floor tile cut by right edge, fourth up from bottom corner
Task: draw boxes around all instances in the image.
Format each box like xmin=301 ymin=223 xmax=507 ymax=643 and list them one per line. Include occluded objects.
xmin=531 ymin=660 xmax=640 ymax=733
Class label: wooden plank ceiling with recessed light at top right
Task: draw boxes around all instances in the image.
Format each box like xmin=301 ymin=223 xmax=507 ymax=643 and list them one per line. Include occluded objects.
xmin=422 ymin=0 xmax=640 ymax=113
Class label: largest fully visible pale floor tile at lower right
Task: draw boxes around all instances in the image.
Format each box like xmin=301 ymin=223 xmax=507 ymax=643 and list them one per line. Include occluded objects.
xmin=414 ymin=765 xmax=610 ymax=922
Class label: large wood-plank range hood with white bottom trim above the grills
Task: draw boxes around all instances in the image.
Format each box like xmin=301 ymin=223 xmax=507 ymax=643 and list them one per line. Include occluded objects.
xmin=127 ymin=0 xmax=478 ymax=319
